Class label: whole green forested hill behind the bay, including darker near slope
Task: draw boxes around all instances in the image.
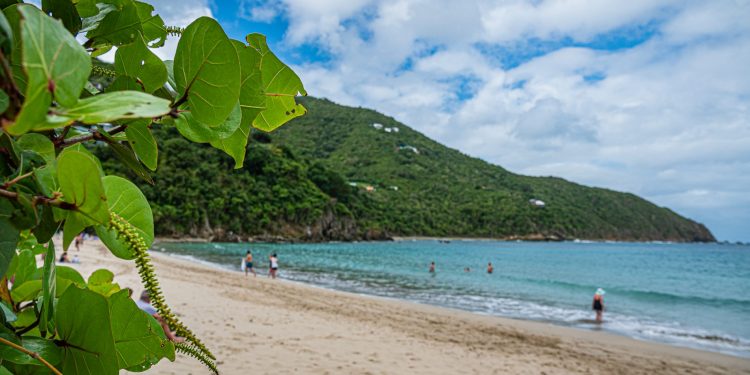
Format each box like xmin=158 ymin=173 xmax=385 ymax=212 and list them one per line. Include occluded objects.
xmin=102 ymin=98 xmax=714 ymax=241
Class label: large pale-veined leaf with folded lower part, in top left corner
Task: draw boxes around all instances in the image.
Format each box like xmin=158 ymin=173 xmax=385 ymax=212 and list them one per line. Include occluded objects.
xmin=6 ymin=5 xmax=91 ymax=135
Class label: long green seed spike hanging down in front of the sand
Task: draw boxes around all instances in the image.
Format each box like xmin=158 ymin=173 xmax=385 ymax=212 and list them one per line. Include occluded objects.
xmin=109 ymin=212 xmax=216 ymax=372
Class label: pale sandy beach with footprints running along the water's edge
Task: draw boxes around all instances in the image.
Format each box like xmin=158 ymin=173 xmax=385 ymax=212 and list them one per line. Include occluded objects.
xmin=58 ymin=239 xmax=750 ymax=374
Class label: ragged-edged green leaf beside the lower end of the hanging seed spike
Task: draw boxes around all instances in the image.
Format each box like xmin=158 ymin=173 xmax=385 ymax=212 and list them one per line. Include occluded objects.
xmin=109 ymin=290 xmax=174 ymax=371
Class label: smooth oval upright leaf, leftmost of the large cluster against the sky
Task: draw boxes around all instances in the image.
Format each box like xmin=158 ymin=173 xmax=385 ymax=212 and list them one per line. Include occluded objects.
xmin=174 ymin=17 xmax=241 ymax=126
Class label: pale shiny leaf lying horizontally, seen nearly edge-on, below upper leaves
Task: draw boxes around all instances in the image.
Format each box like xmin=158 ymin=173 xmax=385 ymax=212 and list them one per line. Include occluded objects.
xmin=56 ymin=91 xmax=171 ymax=124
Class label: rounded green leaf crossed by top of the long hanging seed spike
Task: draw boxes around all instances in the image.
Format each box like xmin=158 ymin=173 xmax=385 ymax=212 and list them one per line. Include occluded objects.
xmin=96 ymin=176 xmax=154 ymax=259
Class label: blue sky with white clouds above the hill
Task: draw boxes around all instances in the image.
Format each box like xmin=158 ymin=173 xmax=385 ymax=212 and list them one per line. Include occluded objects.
xmin=145 ymin=0 xmax=750 ymax=241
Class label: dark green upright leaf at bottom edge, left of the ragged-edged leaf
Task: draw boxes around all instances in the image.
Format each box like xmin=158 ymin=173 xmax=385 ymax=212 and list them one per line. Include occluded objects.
xmin=55 ymin=286 xmax=118 ymax=375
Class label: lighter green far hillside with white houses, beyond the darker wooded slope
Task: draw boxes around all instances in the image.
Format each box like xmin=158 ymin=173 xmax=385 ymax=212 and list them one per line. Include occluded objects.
xmin=271 ymin=98 xmax=714 ymax=241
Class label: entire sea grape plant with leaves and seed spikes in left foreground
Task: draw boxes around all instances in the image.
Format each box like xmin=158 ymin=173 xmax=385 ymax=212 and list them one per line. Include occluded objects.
xmin=0 ymin=0 xmax=306 ymax=374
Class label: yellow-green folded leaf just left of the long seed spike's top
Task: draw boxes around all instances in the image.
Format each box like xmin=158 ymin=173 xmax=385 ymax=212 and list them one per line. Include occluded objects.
xmin=57 ymin=150 xmax=109 ymax=250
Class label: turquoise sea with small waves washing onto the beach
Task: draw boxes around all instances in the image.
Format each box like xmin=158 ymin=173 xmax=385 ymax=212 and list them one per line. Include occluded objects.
xmin=155 ymin=240 xmax=750 ymax=358
